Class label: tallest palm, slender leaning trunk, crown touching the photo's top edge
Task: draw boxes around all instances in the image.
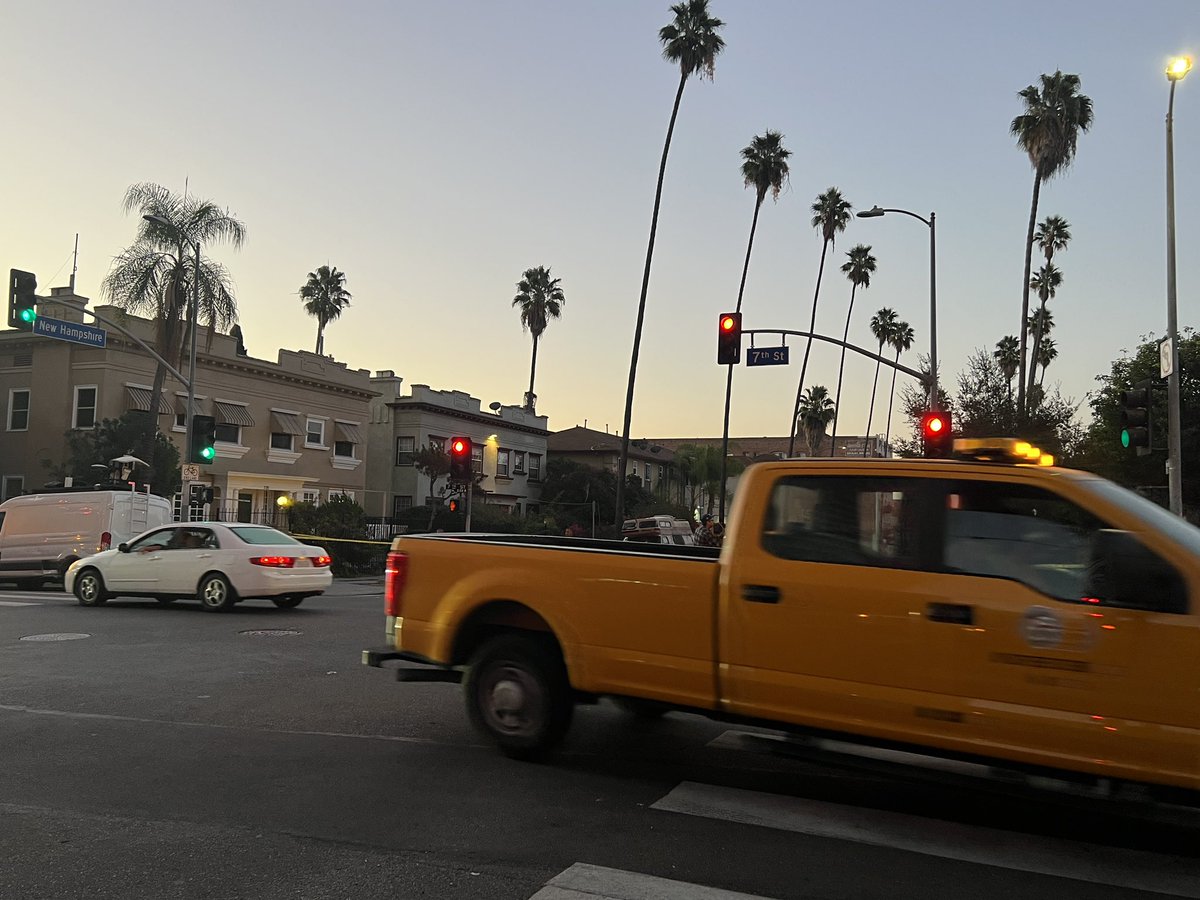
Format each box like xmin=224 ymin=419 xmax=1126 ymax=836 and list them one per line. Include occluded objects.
xmin=616 ymin=0 xmax=725 ymax=526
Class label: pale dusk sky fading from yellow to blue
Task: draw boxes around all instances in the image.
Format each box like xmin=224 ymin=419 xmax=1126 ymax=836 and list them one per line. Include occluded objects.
xmin=0 ymin=0 xmax=1200 ymax=437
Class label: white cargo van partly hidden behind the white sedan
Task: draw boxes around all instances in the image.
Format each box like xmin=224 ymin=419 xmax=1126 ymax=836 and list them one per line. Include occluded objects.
xmin=0 ymin=488 xmax=172 ymax=587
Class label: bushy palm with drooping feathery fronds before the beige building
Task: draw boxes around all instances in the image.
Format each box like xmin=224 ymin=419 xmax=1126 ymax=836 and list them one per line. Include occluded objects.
xmin=101 ymin=181 xmax=246 ymax=434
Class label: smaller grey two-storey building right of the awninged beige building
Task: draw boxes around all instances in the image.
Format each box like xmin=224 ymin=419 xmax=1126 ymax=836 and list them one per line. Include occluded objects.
xmin=364 ymin=371 xmax=548 ymax=518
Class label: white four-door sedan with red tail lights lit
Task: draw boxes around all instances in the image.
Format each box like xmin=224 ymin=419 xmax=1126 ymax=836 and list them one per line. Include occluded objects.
xmin=64 ymin=522 xmax=334 ymax=612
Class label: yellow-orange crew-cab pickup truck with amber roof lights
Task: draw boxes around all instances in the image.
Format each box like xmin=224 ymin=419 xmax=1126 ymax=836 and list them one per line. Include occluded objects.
xmin=364 ymin=439 xmax=1200 ymax=791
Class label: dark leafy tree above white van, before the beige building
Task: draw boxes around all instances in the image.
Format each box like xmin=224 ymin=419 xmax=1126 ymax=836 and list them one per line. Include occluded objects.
xmin=52 ymin=409 xmax=181 ymax=497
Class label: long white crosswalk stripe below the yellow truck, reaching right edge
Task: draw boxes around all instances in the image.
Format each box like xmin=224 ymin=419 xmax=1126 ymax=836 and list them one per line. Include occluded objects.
xmin=652 ymin=781 xmax=1200 ymax=898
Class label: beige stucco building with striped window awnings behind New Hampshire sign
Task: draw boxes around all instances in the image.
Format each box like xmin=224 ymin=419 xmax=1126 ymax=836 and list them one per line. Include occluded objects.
xmin=0 ymin=288 xmax=374 ymax=521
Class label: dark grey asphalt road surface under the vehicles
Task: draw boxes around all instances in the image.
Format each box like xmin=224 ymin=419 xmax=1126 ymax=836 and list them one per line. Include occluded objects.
xmin=0 ymin=581 xmax=1200 ymax=900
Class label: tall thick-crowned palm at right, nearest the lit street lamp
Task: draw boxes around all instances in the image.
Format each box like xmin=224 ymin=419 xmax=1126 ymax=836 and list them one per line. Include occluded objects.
xmin=1009 ymin=71 xmax=1092 ymax=415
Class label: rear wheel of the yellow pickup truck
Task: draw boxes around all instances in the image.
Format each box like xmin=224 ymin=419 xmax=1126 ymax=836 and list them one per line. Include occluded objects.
xmin=463 ymin=635 xmax=575 ymax=760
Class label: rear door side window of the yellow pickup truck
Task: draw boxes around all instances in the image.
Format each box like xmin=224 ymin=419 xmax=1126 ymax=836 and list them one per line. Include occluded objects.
xmin=762 ymin=475 xmax=920 ymax=569
